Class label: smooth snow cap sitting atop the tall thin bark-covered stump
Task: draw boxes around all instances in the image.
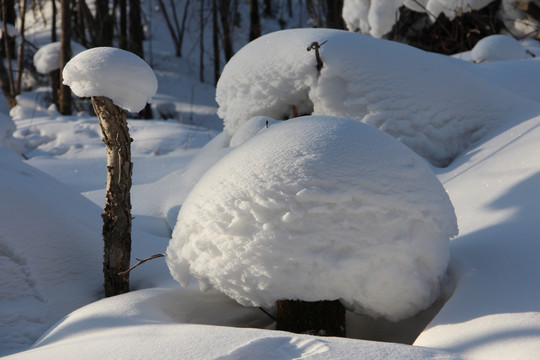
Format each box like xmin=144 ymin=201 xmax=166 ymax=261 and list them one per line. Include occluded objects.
xmin=63 ymin=47 xmax=157 ymax=112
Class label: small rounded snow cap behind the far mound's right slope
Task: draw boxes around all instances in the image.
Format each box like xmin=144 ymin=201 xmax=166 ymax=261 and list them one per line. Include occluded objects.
xmin=471 ymin=35 xmax=530 ymax=64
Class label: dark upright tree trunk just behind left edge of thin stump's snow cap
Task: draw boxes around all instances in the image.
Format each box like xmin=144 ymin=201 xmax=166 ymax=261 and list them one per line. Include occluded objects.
xmin=58 ymin=0 xmax=71 ymax=115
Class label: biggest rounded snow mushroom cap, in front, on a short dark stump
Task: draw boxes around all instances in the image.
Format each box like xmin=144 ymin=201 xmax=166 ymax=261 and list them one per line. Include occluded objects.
xmin=166 ymin=116 xmax=457 ymax=321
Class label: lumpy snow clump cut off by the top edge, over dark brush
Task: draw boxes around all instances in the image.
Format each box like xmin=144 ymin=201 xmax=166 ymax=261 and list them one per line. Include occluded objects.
xmin=342 ymin=0 xmax=502 ymax=38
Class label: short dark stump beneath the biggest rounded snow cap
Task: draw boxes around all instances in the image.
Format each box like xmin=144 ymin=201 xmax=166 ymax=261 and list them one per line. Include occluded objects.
xmin=276 ymin=300 xmax=345 ymax=337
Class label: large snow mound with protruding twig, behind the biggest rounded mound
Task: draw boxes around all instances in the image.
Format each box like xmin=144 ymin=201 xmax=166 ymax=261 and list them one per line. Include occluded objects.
xmin=216 ymin=29 xmax=527 ymax=166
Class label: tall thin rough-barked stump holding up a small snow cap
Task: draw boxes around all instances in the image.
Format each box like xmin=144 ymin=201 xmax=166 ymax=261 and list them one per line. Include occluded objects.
xmin=92 ymin=96 xmax=133 ymax=297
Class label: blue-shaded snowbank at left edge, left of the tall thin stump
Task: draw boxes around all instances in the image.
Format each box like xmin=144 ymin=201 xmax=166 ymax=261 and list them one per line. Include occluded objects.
xmin=0 ymin=146 xmax=103 ymax=354
